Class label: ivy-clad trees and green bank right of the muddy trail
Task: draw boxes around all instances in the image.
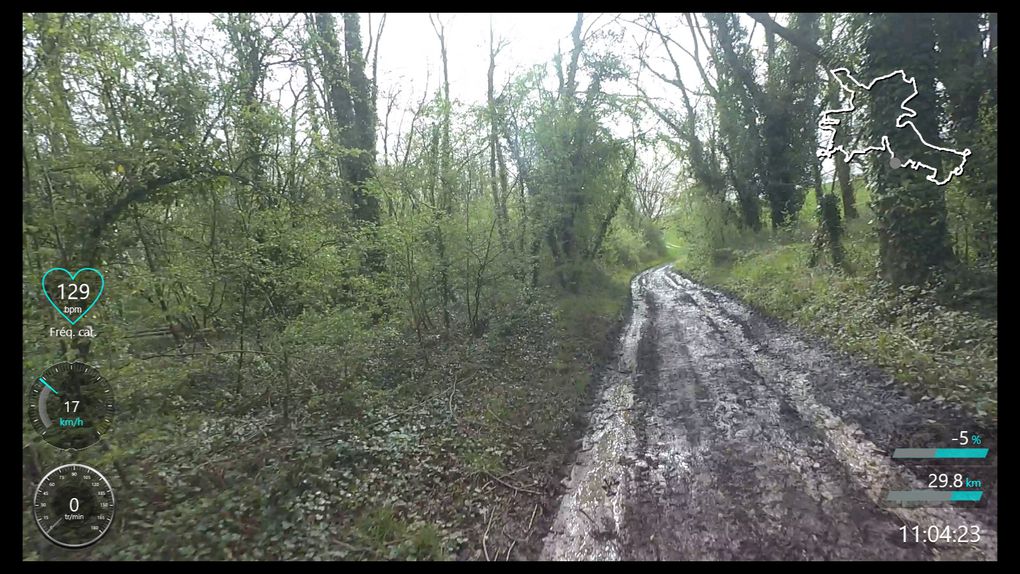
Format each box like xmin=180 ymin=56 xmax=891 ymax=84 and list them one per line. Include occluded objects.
xmin=671 ymin=13 xmax=998 ymax=432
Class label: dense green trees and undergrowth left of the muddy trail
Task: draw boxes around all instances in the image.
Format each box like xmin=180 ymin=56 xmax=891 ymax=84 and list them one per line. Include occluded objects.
xmin=22 ymin=14 xmax=664 ymax=560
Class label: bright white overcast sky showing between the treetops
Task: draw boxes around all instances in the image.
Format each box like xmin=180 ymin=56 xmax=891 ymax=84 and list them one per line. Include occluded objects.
xmin=153 ymin=13 xmax=820 ymax=181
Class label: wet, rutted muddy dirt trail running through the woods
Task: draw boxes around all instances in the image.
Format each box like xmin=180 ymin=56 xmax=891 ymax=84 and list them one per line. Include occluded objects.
xmin=542 ymin=266 xmax=998 ymax=560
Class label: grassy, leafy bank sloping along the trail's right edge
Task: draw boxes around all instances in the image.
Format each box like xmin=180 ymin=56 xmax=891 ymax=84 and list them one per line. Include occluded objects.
xmin=671 ymin=182 xmax=998 ymax=424
